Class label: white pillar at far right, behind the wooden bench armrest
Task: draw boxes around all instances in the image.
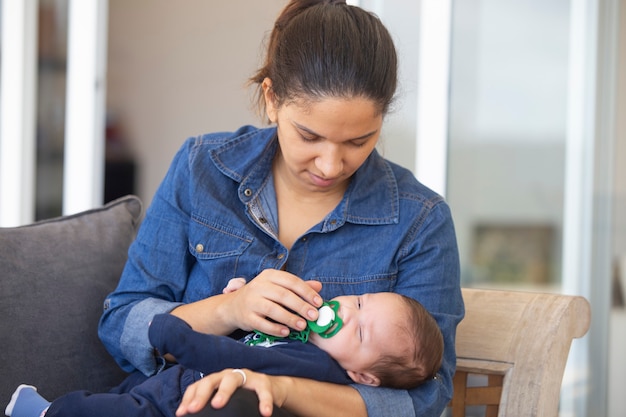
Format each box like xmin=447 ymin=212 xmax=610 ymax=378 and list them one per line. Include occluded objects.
xmin=560 ymin=0 xmax=620 ymax=416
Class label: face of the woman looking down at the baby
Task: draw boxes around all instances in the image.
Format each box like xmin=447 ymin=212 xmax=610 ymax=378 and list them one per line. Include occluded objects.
xmin=264 ymin=80 xmax=383 ymax=197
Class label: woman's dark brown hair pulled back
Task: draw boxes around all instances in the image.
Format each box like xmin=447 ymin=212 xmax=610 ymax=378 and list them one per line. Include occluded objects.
xmin=250 ymin=0 xmax=397 ymax=114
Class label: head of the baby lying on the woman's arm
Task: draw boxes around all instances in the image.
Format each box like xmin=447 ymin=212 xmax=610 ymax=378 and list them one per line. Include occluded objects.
xmin=310 ymin=292 xmax=443 ymax=389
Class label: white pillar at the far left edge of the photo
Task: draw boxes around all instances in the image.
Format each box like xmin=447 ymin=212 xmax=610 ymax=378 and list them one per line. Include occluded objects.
xmin=0 ymin=0 xmax=38 ymax=227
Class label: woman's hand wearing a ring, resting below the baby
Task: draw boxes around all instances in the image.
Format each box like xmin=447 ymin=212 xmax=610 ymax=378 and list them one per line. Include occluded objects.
xmin=176 ymin=369 xmax=286 ymax=416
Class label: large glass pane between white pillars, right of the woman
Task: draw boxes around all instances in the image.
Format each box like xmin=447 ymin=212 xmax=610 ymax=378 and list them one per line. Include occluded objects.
xmin=447 ymin=0 xmax=569 ymax=290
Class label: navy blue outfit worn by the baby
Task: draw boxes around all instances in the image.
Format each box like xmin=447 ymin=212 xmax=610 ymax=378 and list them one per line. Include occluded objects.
xmin=46 ymin=314 xmax=346 ymax=417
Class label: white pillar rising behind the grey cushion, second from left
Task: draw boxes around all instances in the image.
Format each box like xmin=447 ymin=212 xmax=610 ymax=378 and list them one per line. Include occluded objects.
xmin=63 ymin=0 xmax=108 ymax=214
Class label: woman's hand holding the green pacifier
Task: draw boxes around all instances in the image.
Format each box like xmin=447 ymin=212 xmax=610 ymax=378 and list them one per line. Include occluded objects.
xmin=222 ymin=269 xmax=322 ymax=336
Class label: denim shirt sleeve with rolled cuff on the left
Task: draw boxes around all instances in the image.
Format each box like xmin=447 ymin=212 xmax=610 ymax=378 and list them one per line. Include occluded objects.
xmin=98 ymin=137 xmax=193 ymax=375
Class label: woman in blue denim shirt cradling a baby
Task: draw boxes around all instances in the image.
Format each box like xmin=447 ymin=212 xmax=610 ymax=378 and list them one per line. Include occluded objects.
xmin=99 ymin=0 xmax=463 ymax=417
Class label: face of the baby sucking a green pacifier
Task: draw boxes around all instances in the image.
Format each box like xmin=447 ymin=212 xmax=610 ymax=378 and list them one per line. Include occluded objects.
xmin=309 ymin=292 xmax=407 ymax=372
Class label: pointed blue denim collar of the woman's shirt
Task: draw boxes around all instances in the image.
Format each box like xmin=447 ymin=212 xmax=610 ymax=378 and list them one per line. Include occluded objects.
xmin=210 ymin=127 xmax=399 ymax=232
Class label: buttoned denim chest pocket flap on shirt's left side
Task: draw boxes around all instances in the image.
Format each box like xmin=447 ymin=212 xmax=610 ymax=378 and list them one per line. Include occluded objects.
xmin=189 ymin=215 xmax=254 ymax=261
